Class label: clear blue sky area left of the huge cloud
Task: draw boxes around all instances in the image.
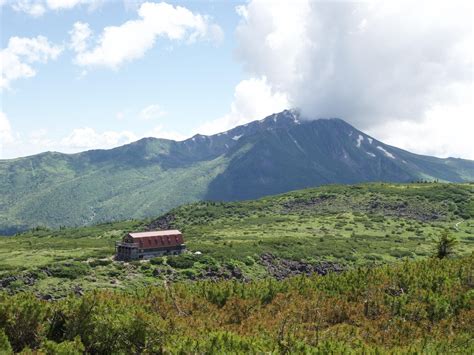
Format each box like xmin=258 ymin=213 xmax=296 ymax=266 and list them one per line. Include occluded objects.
xmin=1 ymin=1 xmax=256 ymax=157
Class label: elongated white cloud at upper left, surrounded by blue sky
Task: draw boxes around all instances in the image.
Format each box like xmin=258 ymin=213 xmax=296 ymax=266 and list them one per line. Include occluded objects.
xmin=71 ymin=2 xmax=222 ymax=69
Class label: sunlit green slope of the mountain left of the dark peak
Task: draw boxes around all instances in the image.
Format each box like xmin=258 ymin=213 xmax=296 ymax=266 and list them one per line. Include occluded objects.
xmin=0 ymin=146 xmax=230 ymax=234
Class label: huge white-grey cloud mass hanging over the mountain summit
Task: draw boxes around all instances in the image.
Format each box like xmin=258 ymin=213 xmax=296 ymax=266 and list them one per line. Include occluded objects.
xmin=237 ymin=0 xmax=474 ymax=159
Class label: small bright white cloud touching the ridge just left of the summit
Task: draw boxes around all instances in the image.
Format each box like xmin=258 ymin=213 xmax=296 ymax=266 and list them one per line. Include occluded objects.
xmin=197 ymin=77 xmax=290 ymax=134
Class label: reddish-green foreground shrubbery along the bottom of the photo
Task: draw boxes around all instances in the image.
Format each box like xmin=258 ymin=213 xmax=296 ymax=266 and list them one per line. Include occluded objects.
xmin=0 ymin=256 xmax=474 ymax=354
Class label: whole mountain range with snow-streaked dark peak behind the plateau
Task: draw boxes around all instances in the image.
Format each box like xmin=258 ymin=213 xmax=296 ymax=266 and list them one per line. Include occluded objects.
xmin=0 ymin=110 xmax=474 ymax=234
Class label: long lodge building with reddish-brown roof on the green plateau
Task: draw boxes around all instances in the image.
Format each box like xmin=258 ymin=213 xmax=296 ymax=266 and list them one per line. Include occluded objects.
xmin=115 ymin=229 xmax=186 ymax=260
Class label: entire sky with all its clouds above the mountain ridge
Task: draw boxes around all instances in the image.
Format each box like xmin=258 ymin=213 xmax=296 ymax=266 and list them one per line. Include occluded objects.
xmin=0 ymin=0 xmax=474 ymax=159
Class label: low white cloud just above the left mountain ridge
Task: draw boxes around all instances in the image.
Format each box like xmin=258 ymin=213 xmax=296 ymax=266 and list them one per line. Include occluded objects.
xmin=59 ymin=127 xmax=137 ymax=151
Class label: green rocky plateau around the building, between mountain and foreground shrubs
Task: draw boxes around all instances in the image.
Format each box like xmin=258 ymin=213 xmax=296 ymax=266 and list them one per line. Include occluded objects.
xmin=0 ymin=183 xmax=474 ymax=297
